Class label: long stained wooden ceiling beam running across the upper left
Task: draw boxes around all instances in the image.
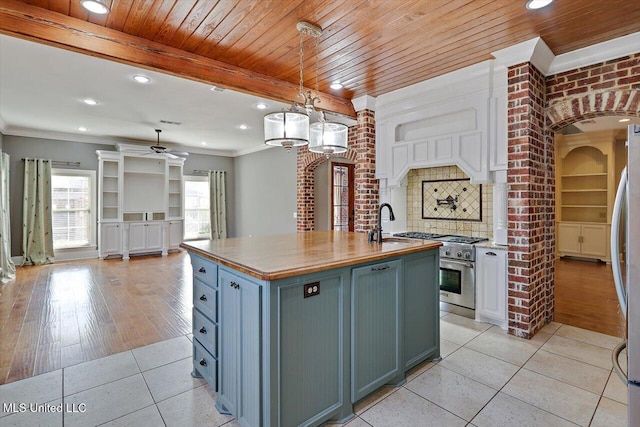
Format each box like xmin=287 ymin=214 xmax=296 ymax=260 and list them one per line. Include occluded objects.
xmin=0 ymin=0 xmax=356 ymax=118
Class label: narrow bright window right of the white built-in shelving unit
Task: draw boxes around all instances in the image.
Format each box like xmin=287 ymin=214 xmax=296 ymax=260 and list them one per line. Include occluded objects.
xmin=184 ymin=176 xmax=211 ymax=240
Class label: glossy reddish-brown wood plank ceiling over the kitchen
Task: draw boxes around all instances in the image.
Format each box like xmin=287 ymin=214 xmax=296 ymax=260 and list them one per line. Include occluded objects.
xmin=0 ymin=0 xmax=640 ymax=115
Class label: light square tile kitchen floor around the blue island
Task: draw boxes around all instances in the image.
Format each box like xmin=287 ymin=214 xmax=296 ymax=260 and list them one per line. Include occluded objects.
xmin=0 ymin=313 xmax=627 ymax=427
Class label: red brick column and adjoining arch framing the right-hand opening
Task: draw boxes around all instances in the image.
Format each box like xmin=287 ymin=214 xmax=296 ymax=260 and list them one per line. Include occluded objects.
xmin=507 ymin=53 xmax=640 ymax=338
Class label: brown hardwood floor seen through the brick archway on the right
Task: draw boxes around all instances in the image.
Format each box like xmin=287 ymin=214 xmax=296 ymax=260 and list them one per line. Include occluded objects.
xmin=555 ymin=259 xmax=625 ymax=337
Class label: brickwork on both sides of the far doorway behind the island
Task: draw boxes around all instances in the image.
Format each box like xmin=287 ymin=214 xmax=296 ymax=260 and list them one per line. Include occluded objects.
xmin=297 ymin=110 xmax=379 ymax=232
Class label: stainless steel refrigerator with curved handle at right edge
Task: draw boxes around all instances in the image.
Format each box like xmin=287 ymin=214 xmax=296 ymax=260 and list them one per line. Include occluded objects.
xmin=611 ymin=125 xmax=640 ymax=427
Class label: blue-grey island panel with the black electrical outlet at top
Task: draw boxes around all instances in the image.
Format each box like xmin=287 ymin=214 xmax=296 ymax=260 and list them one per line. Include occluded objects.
xmin=276 ymin=273 xmax=345 ymax=426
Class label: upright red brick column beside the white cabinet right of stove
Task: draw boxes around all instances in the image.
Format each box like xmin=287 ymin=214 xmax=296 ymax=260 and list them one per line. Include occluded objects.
xmin=507 ymin=63 xmax=554 ymax=338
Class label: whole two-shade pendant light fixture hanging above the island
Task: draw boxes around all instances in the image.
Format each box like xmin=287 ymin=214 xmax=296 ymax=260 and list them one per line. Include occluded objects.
xmin=264 ymin=21 xmax=347 ymax=156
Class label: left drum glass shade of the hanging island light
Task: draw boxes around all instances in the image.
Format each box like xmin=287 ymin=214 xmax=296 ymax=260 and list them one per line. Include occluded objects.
xmin=264 ymin=109 xmax=309 ymax=150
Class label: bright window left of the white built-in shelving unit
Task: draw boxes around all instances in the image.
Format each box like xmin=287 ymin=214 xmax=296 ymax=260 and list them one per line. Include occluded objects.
xmin=51 ymin=169 xmax=96 ymax=249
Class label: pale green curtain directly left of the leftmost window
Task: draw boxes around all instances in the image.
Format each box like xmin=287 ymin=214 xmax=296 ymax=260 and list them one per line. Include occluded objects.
xmin=22 ymin=159 xmax=53 ymax=265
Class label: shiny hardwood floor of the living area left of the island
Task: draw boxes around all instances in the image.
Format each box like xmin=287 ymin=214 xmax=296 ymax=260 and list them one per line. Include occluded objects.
xmin=0 ymin=252 xmax=192 ymax=384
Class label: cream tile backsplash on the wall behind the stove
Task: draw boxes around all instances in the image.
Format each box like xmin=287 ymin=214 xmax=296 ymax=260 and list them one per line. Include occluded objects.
xmin=407 ymin=166 xmax=493 ymax=238
